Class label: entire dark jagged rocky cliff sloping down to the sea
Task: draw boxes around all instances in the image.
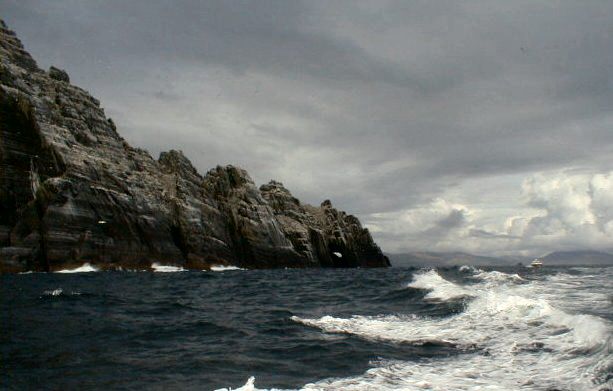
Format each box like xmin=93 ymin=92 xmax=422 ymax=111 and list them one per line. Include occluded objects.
xmin=0 ymin=23 xmax=389 ymax=271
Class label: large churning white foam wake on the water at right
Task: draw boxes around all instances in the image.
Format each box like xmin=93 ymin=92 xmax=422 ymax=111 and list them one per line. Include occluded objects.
xmin=292 ymin=270 xmax=613 ymax=391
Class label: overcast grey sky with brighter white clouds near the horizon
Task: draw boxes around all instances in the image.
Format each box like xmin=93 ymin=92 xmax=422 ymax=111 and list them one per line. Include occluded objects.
xmin=0 ymin=0 xmax=613 ymax=255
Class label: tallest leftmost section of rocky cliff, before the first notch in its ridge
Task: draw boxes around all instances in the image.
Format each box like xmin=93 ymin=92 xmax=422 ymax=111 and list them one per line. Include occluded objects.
xmin=0 ymin=21 xmax=181 ymax=270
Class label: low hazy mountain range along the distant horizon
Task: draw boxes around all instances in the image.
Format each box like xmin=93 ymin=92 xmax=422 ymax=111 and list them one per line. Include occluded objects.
xmin=387 ymin=250 xmax=613 ymax=267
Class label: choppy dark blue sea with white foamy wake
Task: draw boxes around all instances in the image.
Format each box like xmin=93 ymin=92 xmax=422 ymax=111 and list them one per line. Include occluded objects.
xmin=0 ymin=265 xmax=613 ymax=391
